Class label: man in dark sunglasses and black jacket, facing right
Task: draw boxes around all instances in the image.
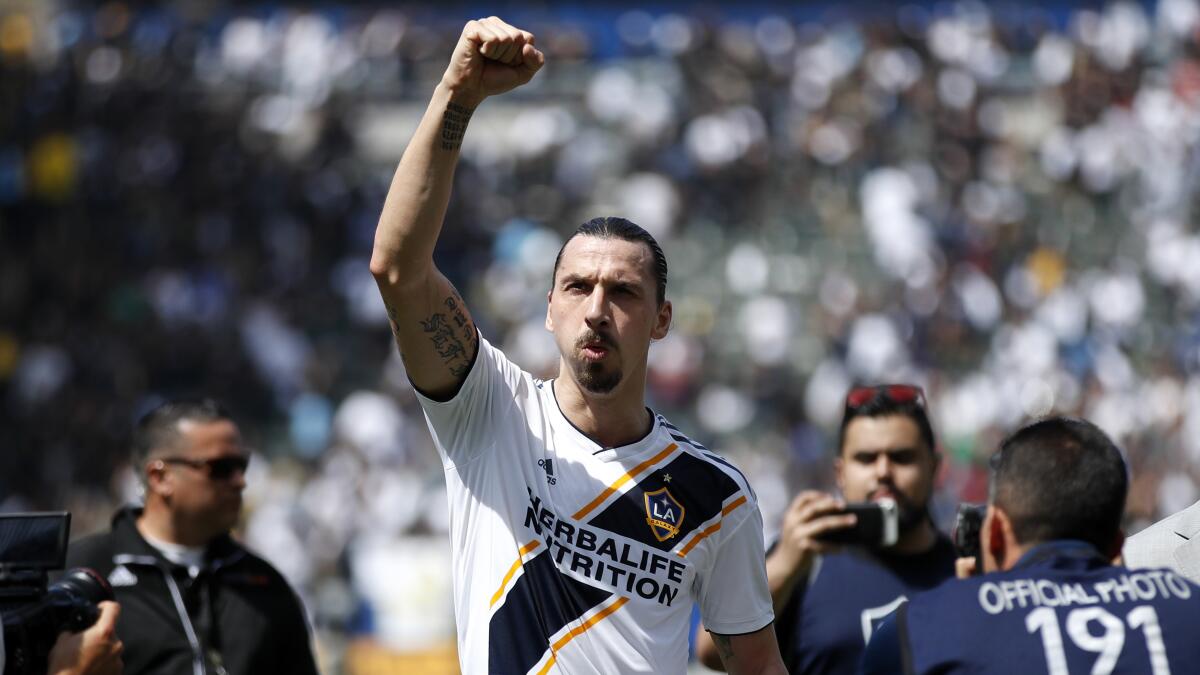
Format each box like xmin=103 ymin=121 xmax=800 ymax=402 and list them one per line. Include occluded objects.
xmin=67 ymin=399 xmax=317 ymax=675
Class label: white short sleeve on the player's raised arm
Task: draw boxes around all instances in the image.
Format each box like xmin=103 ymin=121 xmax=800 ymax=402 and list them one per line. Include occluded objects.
xmin=416 ymin=335 xmax=532 ymax=467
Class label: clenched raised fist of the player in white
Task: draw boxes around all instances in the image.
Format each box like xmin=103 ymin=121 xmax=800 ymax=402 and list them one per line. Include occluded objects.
xmin=442 ymin=17 xmax=546 ymax=107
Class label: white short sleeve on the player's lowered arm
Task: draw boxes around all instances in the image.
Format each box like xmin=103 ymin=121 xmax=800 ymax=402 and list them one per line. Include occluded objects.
xmin=697 ymin=500 xmax=775 ymax=635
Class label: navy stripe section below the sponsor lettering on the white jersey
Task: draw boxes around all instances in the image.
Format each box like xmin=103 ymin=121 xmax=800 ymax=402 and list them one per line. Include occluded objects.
xmin=487 ymin=552 xmax=612 ymax=675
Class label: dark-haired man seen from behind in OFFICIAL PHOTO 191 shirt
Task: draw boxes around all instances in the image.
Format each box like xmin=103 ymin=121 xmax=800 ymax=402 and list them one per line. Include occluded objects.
xmin=863 ymin=417 xmax=1200 ymax=675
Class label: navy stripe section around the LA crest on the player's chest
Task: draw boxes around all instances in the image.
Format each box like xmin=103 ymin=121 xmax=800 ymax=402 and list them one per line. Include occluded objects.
xmin=580 ymin=452 xmax=740 ymax=551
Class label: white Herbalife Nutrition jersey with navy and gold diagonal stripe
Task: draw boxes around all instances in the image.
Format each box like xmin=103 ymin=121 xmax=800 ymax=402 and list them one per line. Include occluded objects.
xmin=420 ymin=338 xmax=773 ymax=675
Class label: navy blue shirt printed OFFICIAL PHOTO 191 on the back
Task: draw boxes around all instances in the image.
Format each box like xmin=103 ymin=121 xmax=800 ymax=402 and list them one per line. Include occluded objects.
xmin=862 ymin=540 xmax=1200 ymax=675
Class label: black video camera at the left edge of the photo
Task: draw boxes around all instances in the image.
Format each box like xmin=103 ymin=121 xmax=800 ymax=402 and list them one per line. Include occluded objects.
xmin=0 ymin=513 xmax=113 ymax=675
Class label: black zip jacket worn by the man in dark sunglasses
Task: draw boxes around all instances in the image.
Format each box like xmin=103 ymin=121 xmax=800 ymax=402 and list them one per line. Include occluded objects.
xmin=67 ymin=508 xmax=317 ymax=675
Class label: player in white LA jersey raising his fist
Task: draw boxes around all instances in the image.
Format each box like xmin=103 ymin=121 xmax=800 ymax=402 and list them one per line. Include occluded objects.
xmin=371 ymin=17 xmax=784 ymax=675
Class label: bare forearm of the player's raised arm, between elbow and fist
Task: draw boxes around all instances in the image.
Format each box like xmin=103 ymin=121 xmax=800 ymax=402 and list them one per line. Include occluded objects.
xmin=371 ymin=84 xmax=478 ymax=286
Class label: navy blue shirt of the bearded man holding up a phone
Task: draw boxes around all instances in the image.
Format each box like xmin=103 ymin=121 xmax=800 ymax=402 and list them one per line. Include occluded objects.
xmin=775 ymin=536 xmax=955 ymax=674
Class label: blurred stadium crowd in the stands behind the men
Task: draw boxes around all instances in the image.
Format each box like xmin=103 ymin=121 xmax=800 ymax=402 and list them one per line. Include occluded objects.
xmin=0 ymin=0 xmax=1200 ymax=674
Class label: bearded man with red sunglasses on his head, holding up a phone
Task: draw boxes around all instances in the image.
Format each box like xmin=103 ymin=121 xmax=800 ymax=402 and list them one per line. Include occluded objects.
xmin=697 ymin=384 xmax=954 ymax=674
